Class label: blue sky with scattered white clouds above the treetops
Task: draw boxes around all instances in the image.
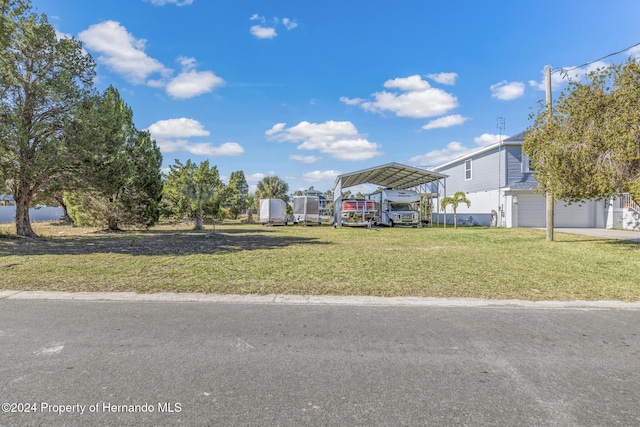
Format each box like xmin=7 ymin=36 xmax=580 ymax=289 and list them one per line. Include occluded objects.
xmin=32 ymin=0 xmax=640 ymax=192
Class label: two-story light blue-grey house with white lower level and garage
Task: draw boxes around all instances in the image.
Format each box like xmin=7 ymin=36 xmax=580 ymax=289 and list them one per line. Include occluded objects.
xmin=434 ymin=132 xmax=623 ymax=228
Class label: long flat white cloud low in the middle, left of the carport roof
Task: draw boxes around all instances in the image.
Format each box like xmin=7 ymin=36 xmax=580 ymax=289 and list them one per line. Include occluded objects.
xmin=265 ymin=120 xmax=383 ymax=160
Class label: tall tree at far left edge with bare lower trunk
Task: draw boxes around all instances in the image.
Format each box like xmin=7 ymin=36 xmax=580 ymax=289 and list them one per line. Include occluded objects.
xmin=0 ymin=0 xmax=95 ymax=237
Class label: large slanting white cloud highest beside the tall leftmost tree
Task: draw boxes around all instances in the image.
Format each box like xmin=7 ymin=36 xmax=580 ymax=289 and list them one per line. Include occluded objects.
xmin=78 ymin=21 xmax=171 ymax=84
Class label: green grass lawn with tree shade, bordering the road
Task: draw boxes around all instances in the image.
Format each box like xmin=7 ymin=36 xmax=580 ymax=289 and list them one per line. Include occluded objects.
xmin=0 ymin=224 xmax=640 ymax=301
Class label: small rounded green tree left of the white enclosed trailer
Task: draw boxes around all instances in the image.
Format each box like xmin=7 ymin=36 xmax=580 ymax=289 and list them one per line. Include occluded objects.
xmin=162 ymin=160 xmax=225 ymax=230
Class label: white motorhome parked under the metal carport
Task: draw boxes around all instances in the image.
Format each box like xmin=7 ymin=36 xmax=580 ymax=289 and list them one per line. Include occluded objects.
xmin=368 ymin=188 xmax=420 ymax=227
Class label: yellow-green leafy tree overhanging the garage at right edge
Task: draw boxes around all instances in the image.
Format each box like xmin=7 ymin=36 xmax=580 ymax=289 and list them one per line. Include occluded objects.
xmin=523 ymin=59 xmax=640 ymax=201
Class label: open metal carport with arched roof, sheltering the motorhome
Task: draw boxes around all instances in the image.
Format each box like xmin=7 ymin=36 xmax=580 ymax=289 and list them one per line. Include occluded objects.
xmin=332 ymin=163 xmax=447 ymax=227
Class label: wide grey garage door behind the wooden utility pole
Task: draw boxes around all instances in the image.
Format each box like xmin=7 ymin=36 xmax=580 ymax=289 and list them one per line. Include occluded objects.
xmin=518 ymin=194 xmax=596 ymax=228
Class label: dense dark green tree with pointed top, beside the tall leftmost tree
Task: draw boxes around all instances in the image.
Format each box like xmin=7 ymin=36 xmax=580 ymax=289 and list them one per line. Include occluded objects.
xmin=64 ymin=87 xmax=162 ymax=230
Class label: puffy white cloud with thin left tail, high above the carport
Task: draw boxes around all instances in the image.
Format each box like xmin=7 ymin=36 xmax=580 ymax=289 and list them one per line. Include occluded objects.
xmin=340 ymin=75 xmax=458 ymax=118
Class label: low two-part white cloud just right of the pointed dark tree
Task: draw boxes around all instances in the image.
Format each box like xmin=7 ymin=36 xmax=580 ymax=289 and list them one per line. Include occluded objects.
xmin=147 ymin=117 xmax=244 ymax=156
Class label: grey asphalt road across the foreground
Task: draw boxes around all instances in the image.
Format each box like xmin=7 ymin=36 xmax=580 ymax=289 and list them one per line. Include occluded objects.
xmin=0 ymin=300 xmax=640 ymax=426
